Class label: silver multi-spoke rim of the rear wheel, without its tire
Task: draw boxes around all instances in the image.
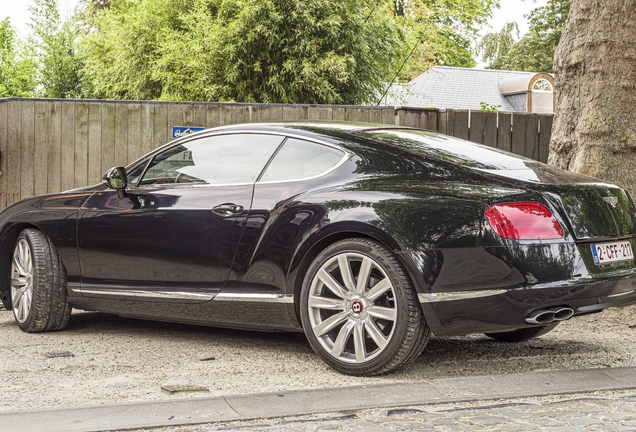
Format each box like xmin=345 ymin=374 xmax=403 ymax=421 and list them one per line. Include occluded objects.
xmin=308 ymin=252 xmax=397 ymax=364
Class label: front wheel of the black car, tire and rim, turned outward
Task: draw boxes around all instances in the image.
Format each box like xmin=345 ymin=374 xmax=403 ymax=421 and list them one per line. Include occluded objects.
xmin=9 ymin=228 xmax=71 ymax=333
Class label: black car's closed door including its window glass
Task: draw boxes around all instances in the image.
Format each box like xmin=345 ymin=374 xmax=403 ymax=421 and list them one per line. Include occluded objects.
xmin=78 ymin=133 xmax=283 ymax=301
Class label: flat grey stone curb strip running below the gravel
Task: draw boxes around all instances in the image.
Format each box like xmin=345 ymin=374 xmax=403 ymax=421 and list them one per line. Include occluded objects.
xmin=0 ymin=367 xmax=636 ymax=432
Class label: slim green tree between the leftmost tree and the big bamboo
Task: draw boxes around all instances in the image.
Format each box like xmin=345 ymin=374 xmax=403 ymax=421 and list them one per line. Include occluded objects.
xmin=29 ymin=0 xmax=83 ymax=98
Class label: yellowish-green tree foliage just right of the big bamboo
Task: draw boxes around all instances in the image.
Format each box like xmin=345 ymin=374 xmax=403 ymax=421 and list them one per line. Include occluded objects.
xmin=392 ymin=0 xmax=499 ymax=80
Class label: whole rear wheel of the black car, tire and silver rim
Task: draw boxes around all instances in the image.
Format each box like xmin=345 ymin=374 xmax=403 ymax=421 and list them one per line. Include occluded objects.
xmin=300 ymin=238 xmax=430 ymax=376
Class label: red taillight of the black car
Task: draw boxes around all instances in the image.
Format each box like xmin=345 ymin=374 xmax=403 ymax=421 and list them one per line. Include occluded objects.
xmin=486 ymin=202 xmax=563 ymax=240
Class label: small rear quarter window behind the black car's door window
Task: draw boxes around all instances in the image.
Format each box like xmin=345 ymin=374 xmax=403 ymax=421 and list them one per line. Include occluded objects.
xmin=261 ymin=138 xmax=345 ymax=182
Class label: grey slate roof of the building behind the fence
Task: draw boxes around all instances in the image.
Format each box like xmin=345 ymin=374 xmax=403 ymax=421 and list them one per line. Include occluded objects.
xmin=386 ymin=66 xmax=536 ymax=111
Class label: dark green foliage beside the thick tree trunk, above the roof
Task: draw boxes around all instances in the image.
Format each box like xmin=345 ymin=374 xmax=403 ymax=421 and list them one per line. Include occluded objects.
xmin=477 ymin=0 xmax=571 ymax=73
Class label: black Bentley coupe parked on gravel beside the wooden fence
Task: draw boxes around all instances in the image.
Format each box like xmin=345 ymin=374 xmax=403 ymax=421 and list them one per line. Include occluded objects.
xmin=0 ymin=122 xmax=636 ymax=375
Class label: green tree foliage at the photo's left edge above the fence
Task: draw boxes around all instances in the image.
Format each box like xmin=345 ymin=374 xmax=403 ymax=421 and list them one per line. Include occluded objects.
xmin=0 ymin=18 xmax=35 ymax=97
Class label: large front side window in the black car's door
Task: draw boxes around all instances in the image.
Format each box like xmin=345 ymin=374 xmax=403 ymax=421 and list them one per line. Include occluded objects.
xmin=139 ymin=134 xmax=284 ymax=186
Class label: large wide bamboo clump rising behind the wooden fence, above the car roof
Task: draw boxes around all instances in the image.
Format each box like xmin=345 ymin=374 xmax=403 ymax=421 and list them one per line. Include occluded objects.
xmin=83 ymin=0 xmax=408 ymax=103
